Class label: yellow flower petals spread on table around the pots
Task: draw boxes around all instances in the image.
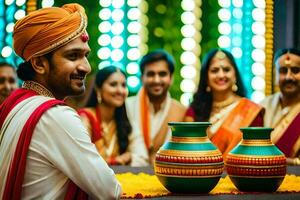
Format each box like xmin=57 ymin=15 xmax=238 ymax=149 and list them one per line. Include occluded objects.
xmin=116 ymin=173 xmax=300 ymax=199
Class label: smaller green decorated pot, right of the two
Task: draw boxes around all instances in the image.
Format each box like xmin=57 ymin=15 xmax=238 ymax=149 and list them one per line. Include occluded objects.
xmin=225 ymin=127 xmax=286 ymax=192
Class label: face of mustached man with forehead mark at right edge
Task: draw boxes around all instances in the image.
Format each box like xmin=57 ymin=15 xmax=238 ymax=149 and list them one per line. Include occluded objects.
xmin=276 ymin=53 xmax=300 ymax=98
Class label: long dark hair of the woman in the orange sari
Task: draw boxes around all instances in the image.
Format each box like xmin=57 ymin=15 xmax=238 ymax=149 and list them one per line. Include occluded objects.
xmin=191 ymin=49 xmax=246 ymax=121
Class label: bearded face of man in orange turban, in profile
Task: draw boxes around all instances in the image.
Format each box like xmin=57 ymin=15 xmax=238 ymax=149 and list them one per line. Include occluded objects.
xmin=46 ymin=37 xmax=91 ymax=99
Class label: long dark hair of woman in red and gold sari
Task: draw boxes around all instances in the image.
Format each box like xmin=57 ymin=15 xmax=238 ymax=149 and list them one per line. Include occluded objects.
xmin=86 ymin=66 xmax=132 ymax=154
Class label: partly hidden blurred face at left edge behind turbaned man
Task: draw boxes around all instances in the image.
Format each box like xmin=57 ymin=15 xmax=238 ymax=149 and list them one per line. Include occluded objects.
xmin=0 ymin=66 xmax=18 ymax=103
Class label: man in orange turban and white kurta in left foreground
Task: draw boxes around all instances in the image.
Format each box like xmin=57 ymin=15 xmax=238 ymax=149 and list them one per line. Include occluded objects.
xmin=0 ymin=4 xmax=121 ymax=200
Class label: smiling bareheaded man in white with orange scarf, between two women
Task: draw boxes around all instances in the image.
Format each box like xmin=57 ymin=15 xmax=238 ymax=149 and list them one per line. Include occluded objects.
xmin=126 ymin=50 xmax=186 ymax=164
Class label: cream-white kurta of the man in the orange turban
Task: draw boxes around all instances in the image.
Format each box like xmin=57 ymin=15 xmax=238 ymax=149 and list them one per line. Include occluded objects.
xmin=0 ymin=96 xmax=121 ymax=199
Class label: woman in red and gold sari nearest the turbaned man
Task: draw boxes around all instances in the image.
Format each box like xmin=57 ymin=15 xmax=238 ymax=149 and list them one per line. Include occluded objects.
xmin=79 ymin=66 xmax=148 ymax=166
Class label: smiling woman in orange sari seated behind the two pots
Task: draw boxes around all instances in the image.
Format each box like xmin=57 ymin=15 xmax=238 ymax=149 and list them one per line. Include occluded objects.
xmin=184 ymin=49 xmax=263 ymax=158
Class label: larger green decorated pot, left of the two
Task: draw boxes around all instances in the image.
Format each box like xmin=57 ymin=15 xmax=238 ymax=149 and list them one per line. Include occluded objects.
xmin=154 ymin=122 xmax=224 ymax=193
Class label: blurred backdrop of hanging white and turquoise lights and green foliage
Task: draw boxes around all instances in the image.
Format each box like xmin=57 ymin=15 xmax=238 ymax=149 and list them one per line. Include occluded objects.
xmin=0 ymin=0 xmax=300 ymax=105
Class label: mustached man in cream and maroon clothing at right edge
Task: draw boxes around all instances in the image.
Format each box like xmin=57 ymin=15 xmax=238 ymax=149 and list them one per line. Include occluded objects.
xmin=261 ymin=49 xmax=300 ymax=165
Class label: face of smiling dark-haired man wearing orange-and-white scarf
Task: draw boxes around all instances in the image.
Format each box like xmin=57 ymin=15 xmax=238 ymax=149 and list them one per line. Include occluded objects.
xmin=142 ymin=60 xmax=172 ymax=99
